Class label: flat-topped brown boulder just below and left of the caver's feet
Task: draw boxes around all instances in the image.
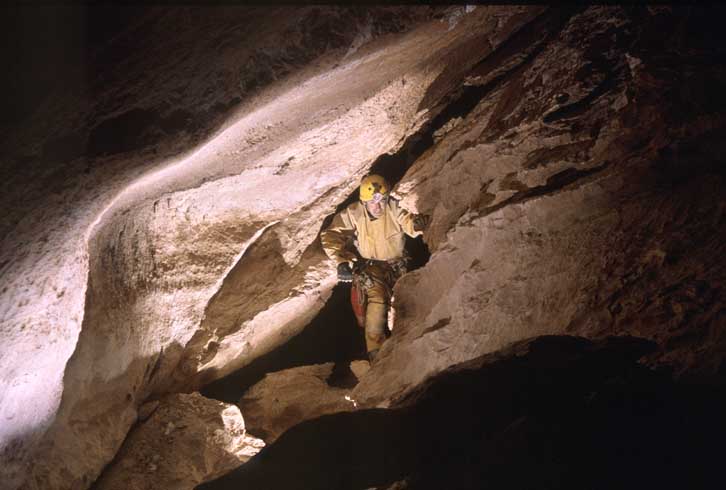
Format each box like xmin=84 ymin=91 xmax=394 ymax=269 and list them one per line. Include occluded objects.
xmin=238 ymin=363 xmax=355 ymax=444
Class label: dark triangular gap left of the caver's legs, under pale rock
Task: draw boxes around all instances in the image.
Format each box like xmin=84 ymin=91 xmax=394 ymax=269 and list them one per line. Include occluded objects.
xmin=201 ymin=284 xmax=367 ymax=403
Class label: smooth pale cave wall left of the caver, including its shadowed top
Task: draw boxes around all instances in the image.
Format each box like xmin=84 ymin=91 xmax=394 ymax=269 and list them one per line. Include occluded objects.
xmin=0 ymin=6 xmax=542 ymax=489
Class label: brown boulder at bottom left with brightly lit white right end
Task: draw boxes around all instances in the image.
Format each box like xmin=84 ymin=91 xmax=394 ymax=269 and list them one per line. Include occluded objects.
xmin=93 ymin=393 xmax=265 ymax=490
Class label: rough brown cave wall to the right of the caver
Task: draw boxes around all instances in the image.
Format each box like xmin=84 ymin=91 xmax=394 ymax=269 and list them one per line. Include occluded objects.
xmin=354 ymin=7 xmax=726 ymax=406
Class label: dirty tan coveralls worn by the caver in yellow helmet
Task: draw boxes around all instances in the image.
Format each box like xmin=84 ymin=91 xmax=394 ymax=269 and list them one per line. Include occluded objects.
xmin=320 ymin=198 xmax=423 ymax=352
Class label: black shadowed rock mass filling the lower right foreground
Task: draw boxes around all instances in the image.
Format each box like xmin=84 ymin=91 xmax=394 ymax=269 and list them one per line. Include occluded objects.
xmin=197 ymin=337 xmax=726 ymax=490
